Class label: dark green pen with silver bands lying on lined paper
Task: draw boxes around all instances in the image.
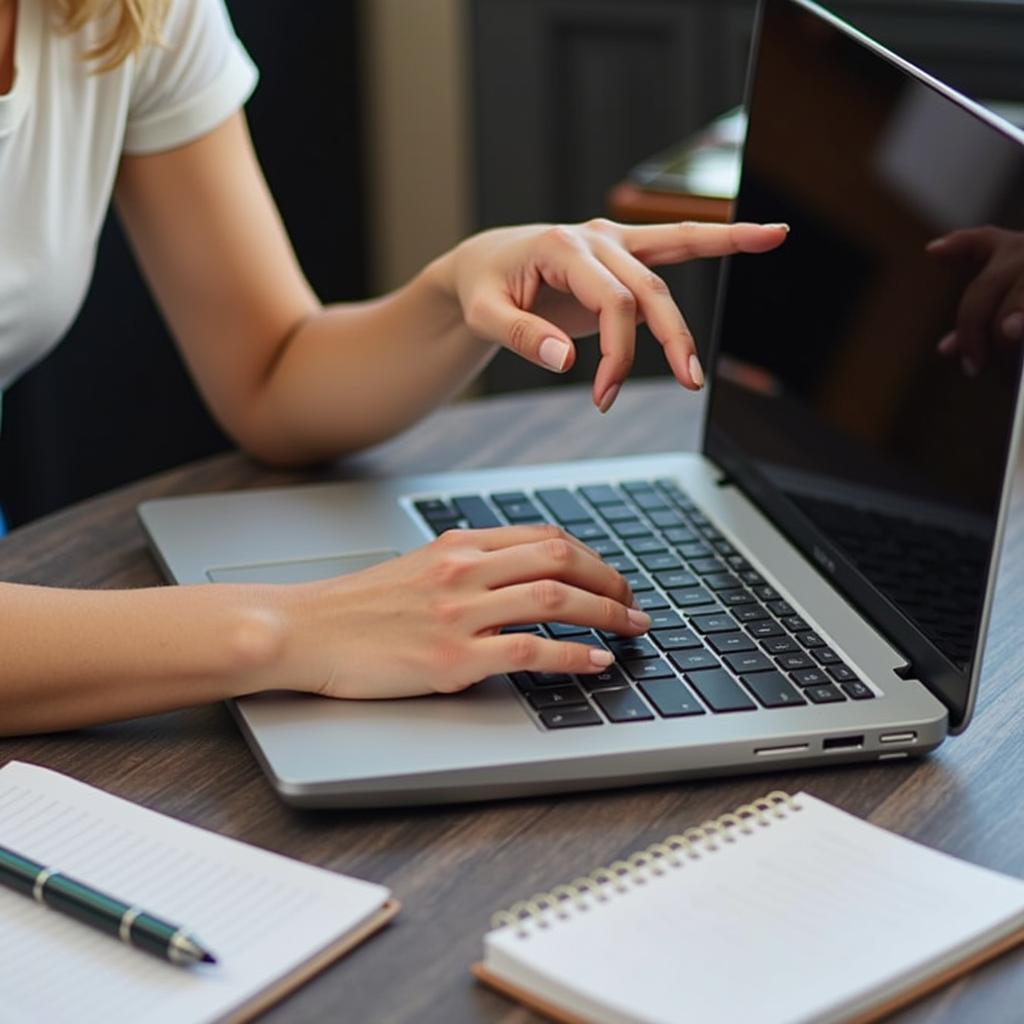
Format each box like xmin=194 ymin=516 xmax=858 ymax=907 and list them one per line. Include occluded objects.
xmin=0 ymin=846 xmax=217 ymax=965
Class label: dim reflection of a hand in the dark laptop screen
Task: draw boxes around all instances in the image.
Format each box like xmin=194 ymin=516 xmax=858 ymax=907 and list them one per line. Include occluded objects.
xmin=927 ymin=227 xmax=1024 ymax=377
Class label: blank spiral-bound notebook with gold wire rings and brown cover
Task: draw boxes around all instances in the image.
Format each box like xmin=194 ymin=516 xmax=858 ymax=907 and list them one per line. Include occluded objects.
xmin=473 ymin=793 xmax=1024 ymax=1024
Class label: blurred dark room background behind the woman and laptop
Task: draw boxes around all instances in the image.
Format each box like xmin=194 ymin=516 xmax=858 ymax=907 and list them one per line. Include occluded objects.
xmin=0 ymin=0 xmax=1024 ymax=525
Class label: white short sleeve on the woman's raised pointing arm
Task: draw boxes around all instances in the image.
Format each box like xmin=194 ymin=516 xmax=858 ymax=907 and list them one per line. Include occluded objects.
xmin=124 ymin=0 xmax=259 ymax=154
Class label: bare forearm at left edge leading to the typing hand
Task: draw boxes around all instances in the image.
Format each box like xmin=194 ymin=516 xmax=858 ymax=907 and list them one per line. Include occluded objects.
xmin=0 ymin=584 xmax=296 ymax=735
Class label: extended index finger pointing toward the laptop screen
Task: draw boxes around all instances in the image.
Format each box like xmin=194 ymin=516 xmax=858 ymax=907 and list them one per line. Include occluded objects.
xmin=622 ymin=221 xmax=790 ymax=266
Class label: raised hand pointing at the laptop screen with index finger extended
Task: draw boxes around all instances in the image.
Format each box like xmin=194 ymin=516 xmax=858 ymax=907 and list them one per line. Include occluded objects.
xmin=434 ymin=219 xmax=788 ymax=413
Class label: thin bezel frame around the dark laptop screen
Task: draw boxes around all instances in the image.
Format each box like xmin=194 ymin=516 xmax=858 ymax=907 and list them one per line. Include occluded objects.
xmin=700 ymin=0 xmax=1024 ymax=734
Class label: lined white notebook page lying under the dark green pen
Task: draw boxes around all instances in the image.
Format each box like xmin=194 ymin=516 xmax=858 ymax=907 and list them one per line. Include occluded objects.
xmin=0 ymin=762 xmax=388 ymax=1024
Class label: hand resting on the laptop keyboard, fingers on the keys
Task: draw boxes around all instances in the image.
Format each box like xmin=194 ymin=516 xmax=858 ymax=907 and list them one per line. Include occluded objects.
xmin=268 ymin=525 xmax=650 ymax=698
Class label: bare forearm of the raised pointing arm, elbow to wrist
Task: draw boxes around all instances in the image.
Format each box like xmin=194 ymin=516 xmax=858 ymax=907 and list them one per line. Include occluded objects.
xmin=244 ymin=253 xmax=496 ymax=464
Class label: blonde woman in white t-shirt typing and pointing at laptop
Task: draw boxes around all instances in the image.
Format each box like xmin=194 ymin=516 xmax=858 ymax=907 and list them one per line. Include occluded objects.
xmin=0 ymin=0 xmax=785 ymax=734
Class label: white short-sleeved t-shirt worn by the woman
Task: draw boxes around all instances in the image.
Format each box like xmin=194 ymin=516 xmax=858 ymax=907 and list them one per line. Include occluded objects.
xmin=0 ymin=0 xmax=257 ymax=391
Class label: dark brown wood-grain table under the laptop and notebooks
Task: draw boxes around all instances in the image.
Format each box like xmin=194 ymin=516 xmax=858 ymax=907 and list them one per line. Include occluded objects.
xmin=0 ymin=381 xmax=1024 ymax=1024
